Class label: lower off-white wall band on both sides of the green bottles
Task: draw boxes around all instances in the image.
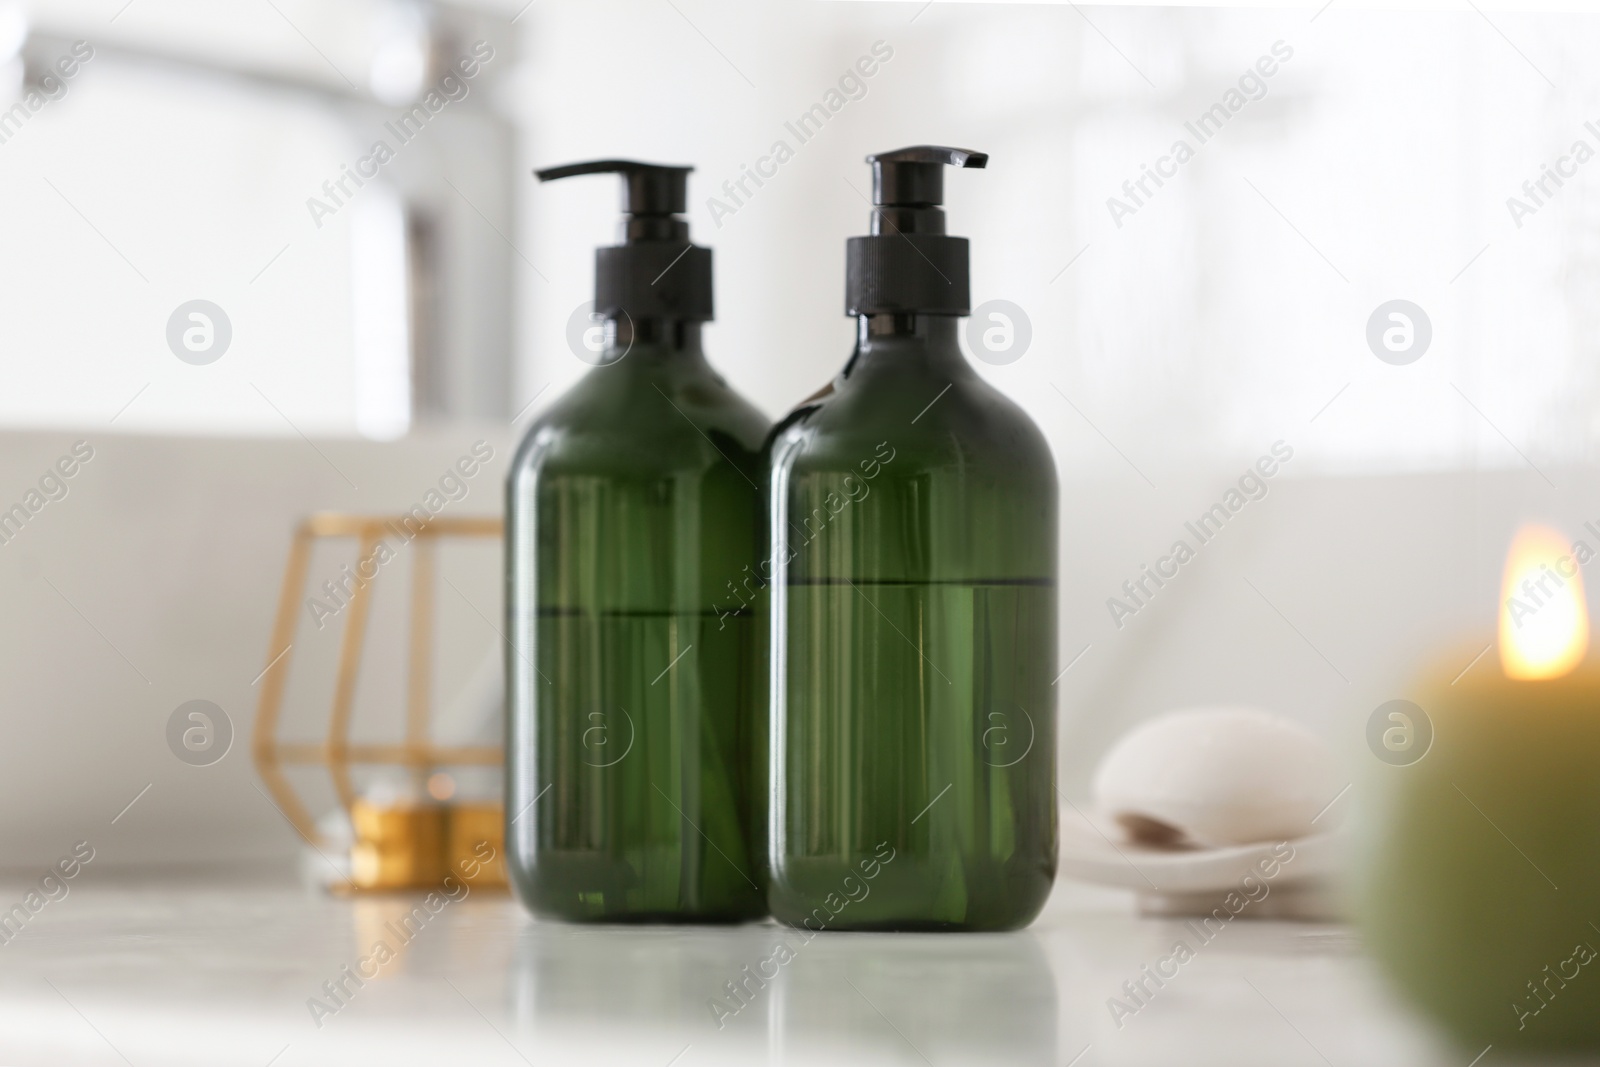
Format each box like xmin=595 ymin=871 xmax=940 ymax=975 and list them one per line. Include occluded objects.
xmin=0 ymin=427 xmax=1600 ymax=867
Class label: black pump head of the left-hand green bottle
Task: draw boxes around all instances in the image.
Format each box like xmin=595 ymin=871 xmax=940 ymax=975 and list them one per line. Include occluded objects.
xmin=534 ymin=160 xmax=712 ymax=323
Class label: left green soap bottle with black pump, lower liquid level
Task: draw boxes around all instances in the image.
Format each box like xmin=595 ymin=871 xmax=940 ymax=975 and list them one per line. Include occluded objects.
xmin=506 ymin=160 xmax=768 ymax=921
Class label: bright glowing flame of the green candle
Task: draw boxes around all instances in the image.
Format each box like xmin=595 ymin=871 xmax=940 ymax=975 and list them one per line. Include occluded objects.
xmin=1499 ymin=526 xmax=1589 ymax=680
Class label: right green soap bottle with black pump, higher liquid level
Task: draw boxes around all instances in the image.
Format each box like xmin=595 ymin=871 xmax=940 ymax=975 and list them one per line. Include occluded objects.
xmin=766 ymin=146 xmax=1058 ymax=931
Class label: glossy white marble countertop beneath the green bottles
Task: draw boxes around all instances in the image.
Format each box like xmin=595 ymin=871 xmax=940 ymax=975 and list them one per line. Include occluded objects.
xmin=0 ymin=872 xmax=1478 ymax=1067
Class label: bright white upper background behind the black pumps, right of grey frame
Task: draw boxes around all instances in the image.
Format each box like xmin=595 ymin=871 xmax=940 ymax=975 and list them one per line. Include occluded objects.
xmin=510 ymin=0 xmax=1600 ymax=483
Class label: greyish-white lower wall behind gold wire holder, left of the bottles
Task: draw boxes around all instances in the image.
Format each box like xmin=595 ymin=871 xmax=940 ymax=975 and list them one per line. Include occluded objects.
xmin=0 ymin=427 xmax=509 ymax=867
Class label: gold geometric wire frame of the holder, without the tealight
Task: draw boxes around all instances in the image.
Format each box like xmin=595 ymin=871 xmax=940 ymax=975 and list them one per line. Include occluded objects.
xmin=251 ymin=512 xmax=504 ymax=848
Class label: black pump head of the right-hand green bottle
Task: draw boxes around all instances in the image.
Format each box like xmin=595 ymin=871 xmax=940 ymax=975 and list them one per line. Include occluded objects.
xmin=845 ymin=144 xmax=989 ymax=315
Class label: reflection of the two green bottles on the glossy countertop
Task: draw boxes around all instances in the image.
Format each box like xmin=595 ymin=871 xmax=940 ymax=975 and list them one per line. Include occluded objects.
xmin=507 ymin=925 xmax=1058 ymax=1064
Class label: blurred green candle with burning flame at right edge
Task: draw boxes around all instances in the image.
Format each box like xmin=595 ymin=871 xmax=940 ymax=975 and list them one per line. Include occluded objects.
xmin=1358 ymin=526 xmax=1600 ymax=1053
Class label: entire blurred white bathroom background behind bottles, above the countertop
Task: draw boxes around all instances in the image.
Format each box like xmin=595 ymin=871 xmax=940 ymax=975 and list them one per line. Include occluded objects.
xmin=0 ymin=0 xmax=1580 ymax=869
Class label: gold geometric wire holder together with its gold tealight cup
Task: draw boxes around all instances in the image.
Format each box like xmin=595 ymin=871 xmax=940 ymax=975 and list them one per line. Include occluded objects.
xmin=251 ymin=512 xmax=506 ymax=889
